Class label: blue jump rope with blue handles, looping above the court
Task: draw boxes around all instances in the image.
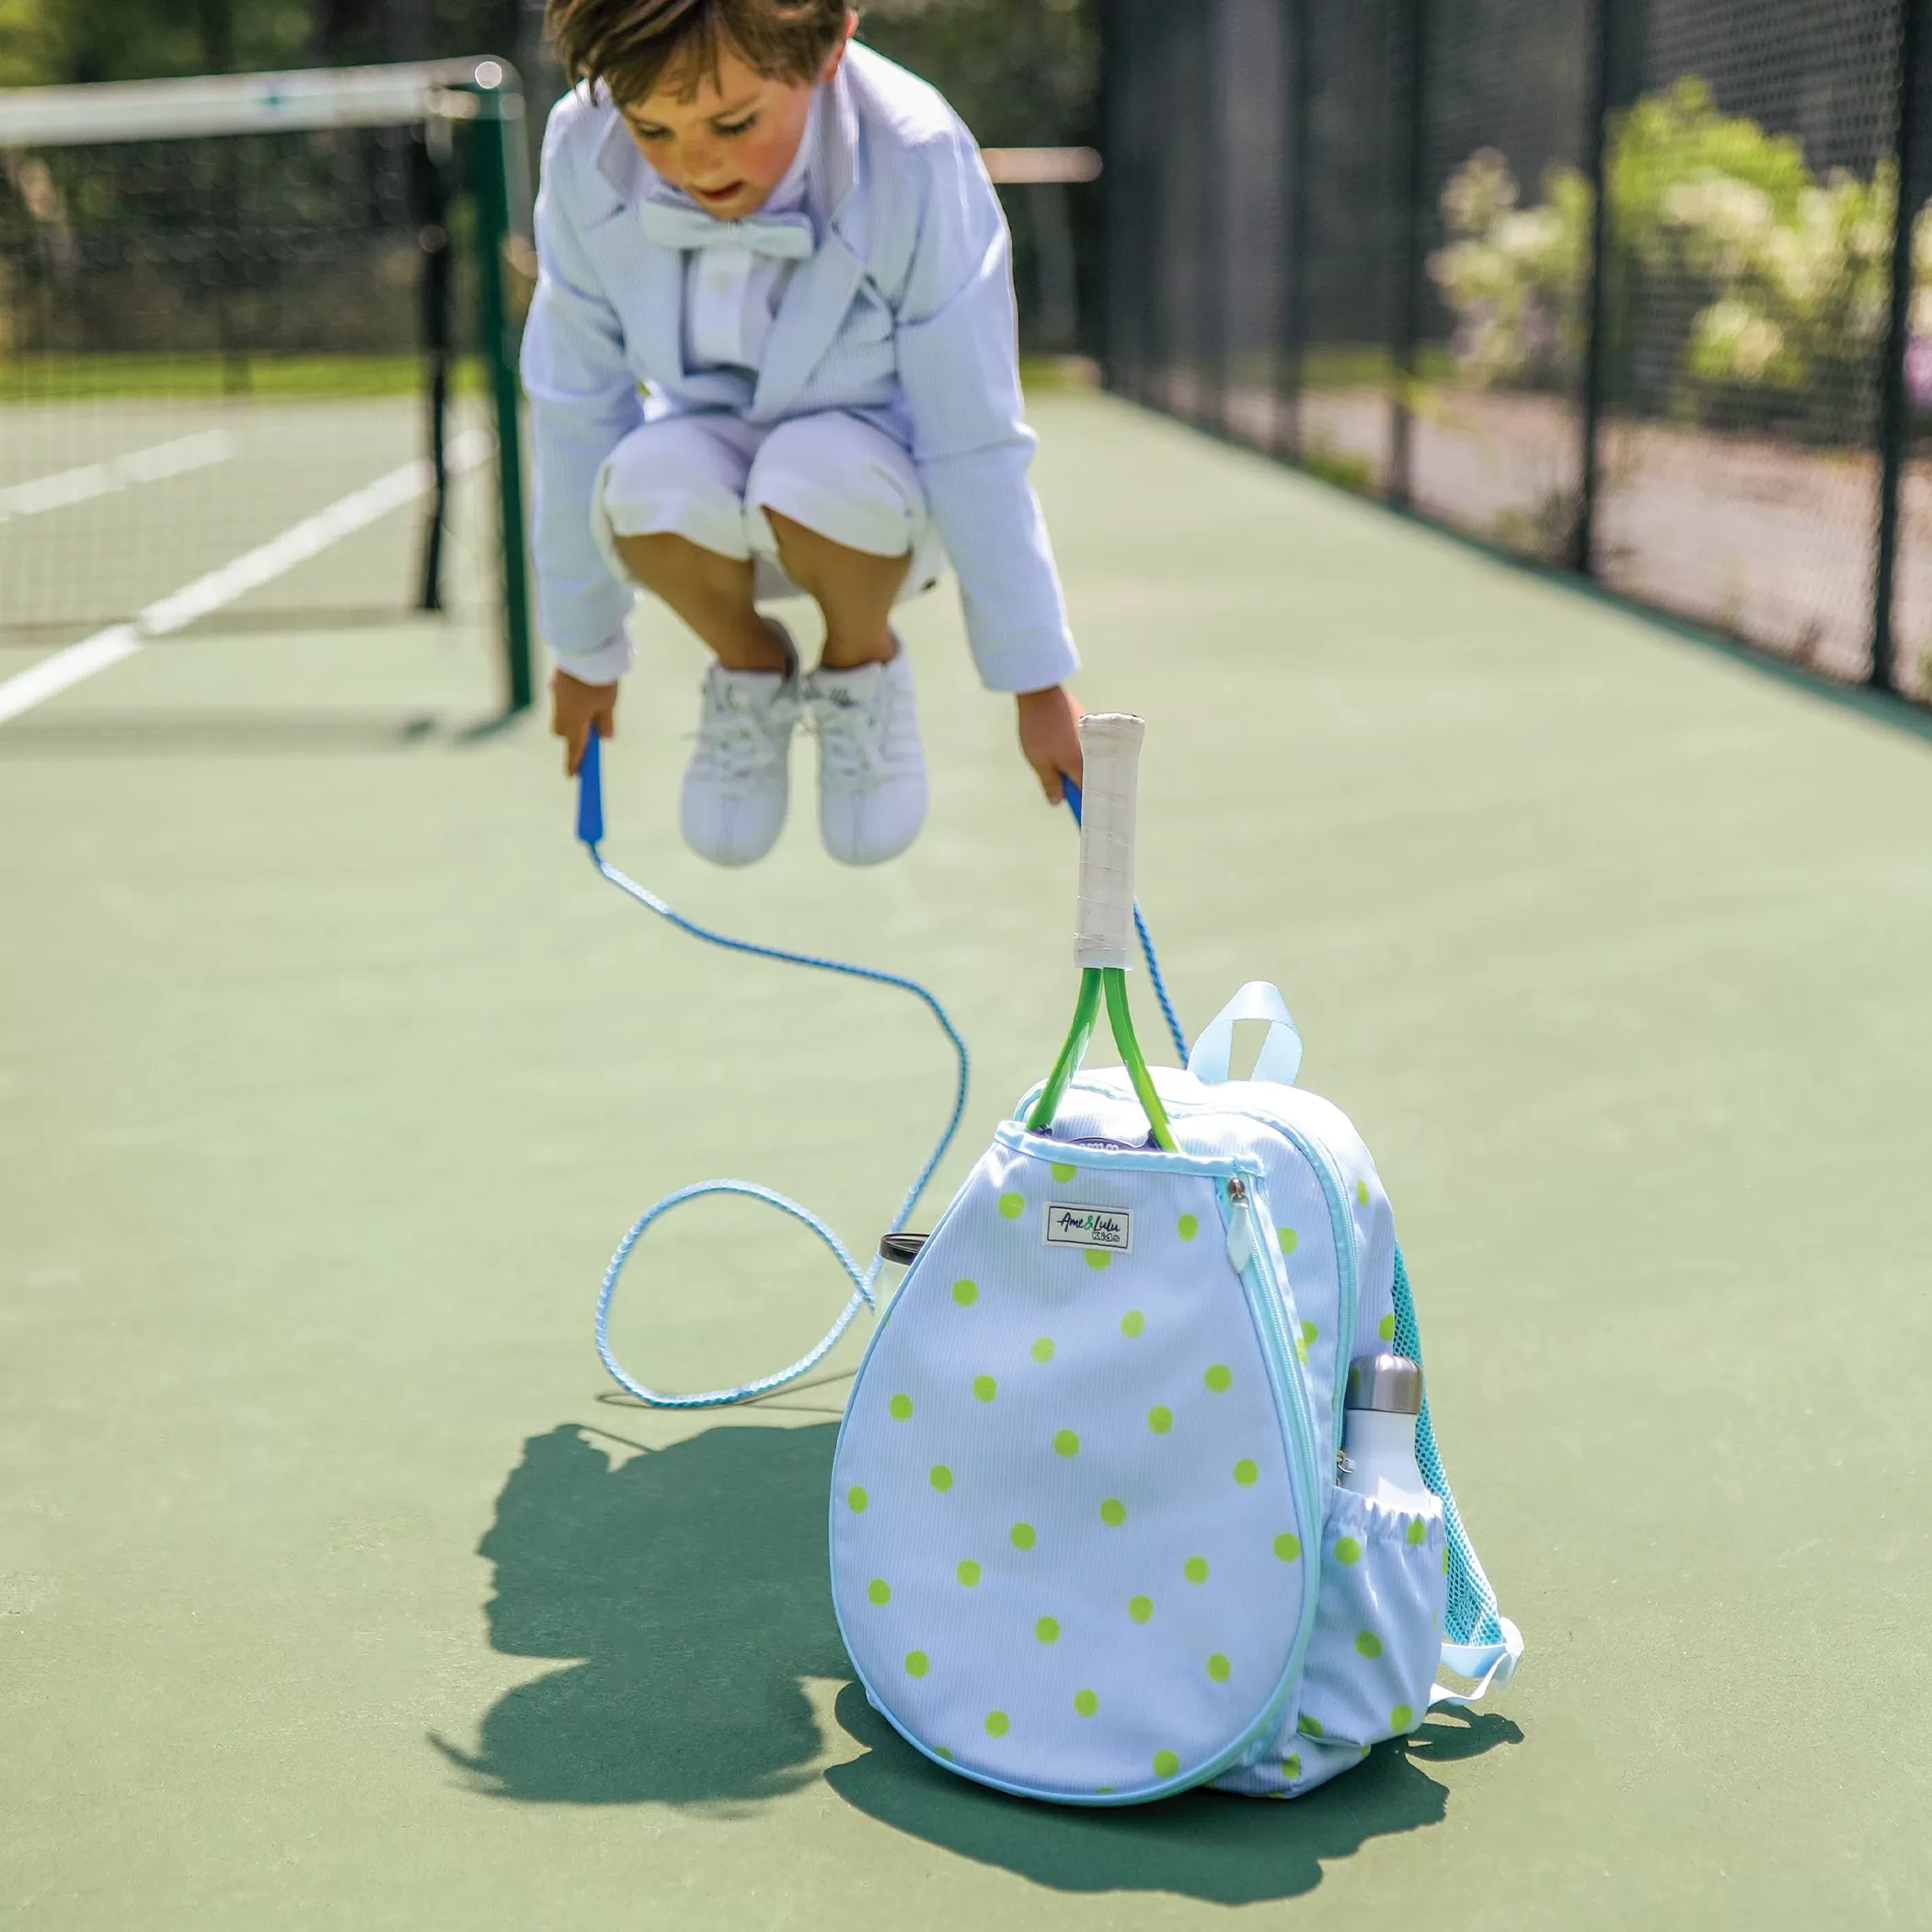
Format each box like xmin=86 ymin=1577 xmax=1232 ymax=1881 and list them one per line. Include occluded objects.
xmin=578 ymin=732 xmax=1189 ymax=1409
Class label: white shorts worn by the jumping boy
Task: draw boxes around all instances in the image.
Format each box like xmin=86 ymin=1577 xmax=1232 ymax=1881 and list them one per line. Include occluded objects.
xmin=592 ymin=409 xmax=947 ymax=603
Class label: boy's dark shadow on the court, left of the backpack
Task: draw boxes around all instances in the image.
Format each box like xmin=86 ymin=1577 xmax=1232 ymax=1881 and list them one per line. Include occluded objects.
xmin=439 ymin=1422 xmax=850 ymax=1804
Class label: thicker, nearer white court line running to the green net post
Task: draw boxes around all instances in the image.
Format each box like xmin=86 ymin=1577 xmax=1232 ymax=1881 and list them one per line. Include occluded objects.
xmin=0 ymin=429 xmax=495 ymax=725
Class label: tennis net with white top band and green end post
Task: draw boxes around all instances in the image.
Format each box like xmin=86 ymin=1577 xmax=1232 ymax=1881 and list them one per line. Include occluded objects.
xmin=0 ymin=60 xmax=529 ymax=709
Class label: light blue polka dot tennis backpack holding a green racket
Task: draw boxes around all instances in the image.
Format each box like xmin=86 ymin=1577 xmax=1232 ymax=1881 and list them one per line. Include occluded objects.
xmin=831 ymin=719 xmax=1523 ymax=1804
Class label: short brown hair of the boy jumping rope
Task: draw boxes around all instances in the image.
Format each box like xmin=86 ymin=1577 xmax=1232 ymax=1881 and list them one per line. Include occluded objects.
xmin=543 ymin=0 xmax=848 ymax=104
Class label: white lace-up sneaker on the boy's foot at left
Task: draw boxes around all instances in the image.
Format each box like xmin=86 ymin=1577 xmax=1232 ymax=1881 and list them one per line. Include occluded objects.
xmin=678 ymin=664 xmax=802 ymax=866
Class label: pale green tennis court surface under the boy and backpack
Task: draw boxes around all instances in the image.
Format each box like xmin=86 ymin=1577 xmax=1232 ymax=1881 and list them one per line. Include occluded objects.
xmin=0 ymin=397 xmax=1932 ymax=1932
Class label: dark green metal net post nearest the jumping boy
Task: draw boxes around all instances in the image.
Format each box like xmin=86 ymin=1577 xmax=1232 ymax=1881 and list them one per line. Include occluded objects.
xmin=469 ymin=60 xmax=532 ymax=715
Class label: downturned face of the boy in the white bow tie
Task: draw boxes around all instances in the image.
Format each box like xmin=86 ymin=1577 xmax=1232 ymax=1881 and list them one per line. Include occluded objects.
xmin=618 ymin=19 xmax=856 ymax=223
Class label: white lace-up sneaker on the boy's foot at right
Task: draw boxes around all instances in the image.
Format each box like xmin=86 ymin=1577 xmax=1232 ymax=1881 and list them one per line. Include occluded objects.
xmin=804 ymin=648 xmax=926 ymax=866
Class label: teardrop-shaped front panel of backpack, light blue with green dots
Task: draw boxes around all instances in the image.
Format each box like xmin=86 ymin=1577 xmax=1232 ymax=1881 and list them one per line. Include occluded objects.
xmin=831 ymin=1144 xmax=1321 ymax=1800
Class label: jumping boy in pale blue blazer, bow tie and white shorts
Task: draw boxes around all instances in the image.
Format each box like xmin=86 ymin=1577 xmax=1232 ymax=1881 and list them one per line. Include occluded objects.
xmin=523 ymin=0 xmax=1080 ymax=866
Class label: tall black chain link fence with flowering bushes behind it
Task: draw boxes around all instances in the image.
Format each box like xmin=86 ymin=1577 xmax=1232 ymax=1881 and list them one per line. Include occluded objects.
xmin=1105 ymin=0 xmax=1932 ymax=701
